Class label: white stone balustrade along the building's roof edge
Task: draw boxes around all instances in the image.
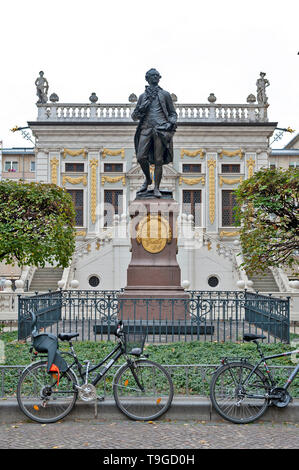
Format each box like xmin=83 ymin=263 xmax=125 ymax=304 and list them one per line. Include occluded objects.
xmin=37 ymin=103 xmax=268 ymax=123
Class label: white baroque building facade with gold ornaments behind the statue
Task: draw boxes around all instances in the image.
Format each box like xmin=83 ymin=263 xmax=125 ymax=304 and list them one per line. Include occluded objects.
xmin=28 ymin=89 xmax=277 ymax=290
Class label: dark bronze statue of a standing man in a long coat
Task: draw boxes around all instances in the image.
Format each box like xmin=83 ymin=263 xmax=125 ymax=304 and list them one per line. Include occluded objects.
xmin=132 ymin=69 xmax=177 ymax=197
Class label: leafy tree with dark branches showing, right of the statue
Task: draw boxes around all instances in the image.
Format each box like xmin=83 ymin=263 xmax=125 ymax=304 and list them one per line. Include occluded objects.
xmin=236 ymin=169 xmax=299 ymax=274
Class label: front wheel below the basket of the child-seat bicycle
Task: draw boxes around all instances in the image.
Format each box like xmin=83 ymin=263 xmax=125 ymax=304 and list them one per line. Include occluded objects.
xmin=113 ymin=359 xmax=173 ymax=421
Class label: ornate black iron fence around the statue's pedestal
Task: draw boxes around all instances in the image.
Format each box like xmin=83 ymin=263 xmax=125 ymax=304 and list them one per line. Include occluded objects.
xmin=18 ymin=290 xmax=290 ymax=343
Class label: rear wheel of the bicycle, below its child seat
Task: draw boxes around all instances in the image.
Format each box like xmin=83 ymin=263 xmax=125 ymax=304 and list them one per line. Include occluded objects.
xmin=17 ymin=362 xmax=78 ymax=423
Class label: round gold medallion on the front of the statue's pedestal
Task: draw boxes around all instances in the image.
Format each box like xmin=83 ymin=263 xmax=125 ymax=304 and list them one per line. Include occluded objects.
xmin=136 ymin=214 xmax=172 ymax=253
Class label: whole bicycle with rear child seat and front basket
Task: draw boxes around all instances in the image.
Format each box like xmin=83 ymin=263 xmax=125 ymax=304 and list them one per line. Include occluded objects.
xmin=17 ymin=314 xmax=173 ymax=423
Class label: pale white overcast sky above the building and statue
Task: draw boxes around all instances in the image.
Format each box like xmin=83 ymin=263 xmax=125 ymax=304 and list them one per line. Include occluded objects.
xmin=0 ymin=0 xmax=299 ymax=148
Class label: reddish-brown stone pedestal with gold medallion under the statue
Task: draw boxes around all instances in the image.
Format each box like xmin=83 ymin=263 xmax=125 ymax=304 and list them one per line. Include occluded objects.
xmin=119 ymin=198 xmax=189 ymax=320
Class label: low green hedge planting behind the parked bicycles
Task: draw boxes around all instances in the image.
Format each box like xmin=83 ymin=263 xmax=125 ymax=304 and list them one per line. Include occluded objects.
xmin=0 ymin=332 xmax=299 ymax=397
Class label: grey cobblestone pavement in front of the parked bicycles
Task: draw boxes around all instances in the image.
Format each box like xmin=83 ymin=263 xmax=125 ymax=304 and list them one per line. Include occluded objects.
xmin=0 ymin=420 xmax=299 ymax=449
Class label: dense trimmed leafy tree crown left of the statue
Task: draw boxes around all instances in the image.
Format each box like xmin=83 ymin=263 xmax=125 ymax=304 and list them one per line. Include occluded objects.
xmin=0 ymin=180 xmax=75 ymax=267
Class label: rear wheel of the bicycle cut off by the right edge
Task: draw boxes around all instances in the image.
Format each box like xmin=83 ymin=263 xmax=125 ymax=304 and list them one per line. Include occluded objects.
xmin=210 ymin=362 xmax=269 ymax=424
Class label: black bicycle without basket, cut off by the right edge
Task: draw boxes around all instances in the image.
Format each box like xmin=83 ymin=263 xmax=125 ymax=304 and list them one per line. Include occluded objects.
xmin=210 ymin=334 xmax=299 ymax=424
